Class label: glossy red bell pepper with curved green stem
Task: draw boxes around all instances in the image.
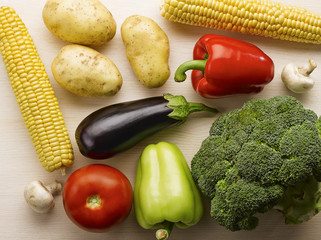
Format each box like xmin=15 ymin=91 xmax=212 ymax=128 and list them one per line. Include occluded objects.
xmin=175 ymin=34 xmax=274 ymax=98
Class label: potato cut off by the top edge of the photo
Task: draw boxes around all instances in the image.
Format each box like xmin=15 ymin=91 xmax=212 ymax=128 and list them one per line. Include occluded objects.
xmin=42 ymin=0 xmax=116 ymax=46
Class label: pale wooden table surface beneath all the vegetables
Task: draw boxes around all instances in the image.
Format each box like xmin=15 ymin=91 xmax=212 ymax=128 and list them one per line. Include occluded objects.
xmin=0 ymin=0 xmax=321 ymax=240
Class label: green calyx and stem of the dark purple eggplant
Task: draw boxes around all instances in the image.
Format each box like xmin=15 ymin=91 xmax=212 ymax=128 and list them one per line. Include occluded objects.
xmin=164 ymin=94 xmax=218 ymax=121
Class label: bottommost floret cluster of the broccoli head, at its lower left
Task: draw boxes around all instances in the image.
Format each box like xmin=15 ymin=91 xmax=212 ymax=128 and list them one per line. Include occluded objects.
xmin=211 ymin=179 xmax=284 ymax=231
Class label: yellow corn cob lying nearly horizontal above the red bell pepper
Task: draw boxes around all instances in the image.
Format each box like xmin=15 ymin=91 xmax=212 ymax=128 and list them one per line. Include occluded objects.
xmin=161 ymin=0 xmax=321 ymax=44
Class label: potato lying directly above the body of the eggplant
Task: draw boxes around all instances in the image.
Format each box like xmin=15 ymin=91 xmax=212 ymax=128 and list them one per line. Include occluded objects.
xmin=51 ymin=44 xmax=123 ymax=97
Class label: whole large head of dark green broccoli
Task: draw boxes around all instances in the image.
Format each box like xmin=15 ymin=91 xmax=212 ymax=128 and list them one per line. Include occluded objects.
xmin=191 ymin=96 xmax=321 ymax=231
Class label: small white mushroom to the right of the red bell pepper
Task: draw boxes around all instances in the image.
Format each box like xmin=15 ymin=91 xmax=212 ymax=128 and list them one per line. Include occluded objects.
xmin=281 ymin=59 xmax=317 ymax=93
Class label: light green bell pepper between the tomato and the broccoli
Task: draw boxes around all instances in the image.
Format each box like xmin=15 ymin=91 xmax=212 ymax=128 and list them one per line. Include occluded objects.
xmin=134 ymin=142 xmax=203 ymax=240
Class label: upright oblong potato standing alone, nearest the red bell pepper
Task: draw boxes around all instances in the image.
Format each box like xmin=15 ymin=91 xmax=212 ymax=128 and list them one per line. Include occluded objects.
xmin=121 ymin=15 xmax=170 ymax=88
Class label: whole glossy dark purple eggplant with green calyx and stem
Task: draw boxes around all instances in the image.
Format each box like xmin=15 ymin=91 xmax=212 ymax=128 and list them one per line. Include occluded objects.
xmin=75 ymin=94 xmax=217 ymax=159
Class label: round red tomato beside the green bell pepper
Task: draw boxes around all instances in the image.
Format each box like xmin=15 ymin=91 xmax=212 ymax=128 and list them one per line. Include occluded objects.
xmin=63 ymin=164 xmax=133 ymax=232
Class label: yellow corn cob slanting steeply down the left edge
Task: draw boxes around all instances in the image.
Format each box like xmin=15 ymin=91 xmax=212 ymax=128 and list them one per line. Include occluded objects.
xmin=0 ymin=7 xmax=73 ymax=172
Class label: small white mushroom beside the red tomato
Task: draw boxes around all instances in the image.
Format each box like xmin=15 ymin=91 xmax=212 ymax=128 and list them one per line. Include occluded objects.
xmin=24 ymin=181 xmax=62 ymax=213
